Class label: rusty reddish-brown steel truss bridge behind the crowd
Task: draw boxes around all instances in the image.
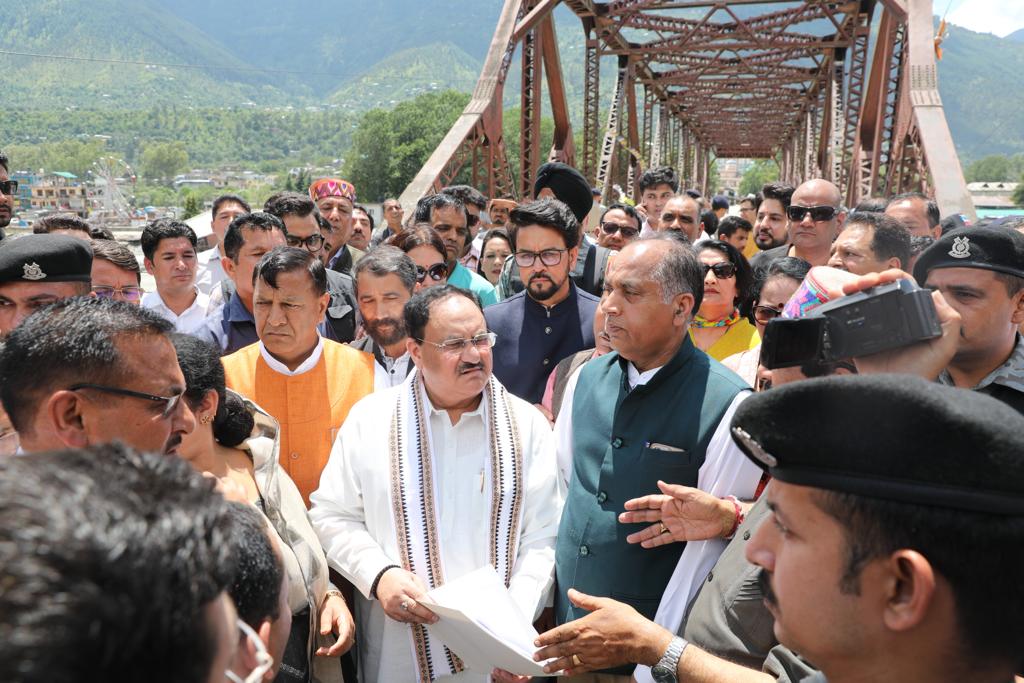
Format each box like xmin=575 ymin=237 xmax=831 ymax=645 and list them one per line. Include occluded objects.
xmin=400 ymin=0 xmax=974 ymax=217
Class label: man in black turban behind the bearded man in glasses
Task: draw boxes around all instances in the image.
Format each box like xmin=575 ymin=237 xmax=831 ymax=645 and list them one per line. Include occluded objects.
xmin=498 ymin=162 xmax=611 ymax=299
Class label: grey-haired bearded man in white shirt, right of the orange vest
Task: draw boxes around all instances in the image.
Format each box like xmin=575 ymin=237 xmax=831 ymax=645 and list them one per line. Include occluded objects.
xmin=351 ymin=245 xmax=417 ymax=391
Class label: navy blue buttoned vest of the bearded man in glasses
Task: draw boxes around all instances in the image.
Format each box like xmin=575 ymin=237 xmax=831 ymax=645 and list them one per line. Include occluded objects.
xmin=483 ymin=281 xmax=600 ymax=403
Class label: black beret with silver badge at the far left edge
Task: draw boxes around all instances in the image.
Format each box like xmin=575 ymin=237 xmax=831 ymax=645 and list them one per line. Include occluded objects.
xmin=0 ymin=233 xmax=92 ymax=283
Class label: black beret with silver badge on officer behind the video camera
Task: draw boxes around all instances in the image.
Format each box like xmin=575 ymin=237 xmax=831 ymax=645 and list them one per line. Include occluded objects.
xmin=913 ymin=227 xmax=1024 ymax=285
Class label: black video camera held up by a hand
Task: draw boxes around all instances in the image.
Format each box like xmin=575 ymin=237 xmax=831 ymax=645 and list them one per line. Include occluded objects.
xmin=761 ymin=280 xmax=942 ymax=370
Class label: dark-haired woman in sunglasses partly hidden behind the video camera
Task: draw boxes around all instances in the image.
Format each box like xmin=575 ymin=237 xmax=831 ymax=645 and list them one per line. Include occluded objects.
xmin=722 ymin=256 xmax=811 ymax=387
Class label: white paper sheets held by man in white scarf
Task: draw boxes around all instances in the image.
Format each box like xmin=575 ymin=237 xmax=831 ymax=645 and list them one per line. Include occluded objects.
xmin=420 ymin=564 xmax=550 ymax=676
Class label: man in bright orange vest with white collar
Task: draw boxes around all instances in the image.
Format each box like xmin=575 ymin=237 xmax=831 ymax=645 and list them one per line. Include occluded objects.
xmin=223 ymin=247 xmax=374 ymax=505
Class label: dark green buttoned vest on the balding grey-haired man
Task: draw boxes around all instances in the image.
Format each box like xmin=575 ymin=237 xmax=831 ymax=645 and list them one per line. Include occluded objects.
xmin=555 ymin=337 xmax=749 ymax=669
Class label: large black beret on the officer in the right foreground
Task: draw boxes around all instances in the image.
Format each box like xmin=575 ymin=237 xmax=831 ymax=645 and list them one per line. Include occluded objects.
xmin=732 ymin=375 xmax=1024 ymax=516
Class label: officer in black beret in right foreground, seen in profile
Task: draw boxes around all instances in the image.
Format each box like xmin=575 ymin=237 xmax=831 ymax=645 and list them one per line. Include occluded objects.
xmin=732 ymin=375 xmax=1024 ymax=683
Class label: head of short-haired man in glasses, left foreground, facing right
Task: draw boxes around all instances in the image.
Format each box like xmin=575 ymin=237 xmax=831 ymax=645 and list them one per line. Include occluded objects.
xmin=0 ymin=296 xmax=196 ymax=454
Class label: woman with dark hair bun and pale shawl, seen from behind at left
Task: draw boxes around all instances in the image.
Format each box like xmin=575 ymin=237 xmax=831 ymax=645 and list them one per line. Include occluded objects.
xmin=171 ymin=334 xmax=354 ymax=681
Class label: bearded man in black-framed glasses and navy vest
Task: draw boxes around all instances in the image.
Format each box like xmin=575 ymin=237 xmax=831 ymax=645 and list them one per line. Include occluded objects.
xmin=484 ymin=199 xmax=600 ymax=403
